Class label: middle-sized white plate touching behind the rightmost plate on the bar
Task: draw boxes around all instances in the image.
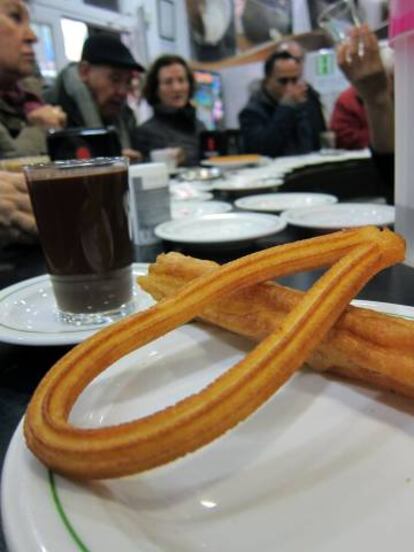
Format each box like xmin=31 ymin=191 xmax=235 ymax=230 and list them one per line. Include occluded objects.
xmin=234 ymin=192 xmax=338 ymax=213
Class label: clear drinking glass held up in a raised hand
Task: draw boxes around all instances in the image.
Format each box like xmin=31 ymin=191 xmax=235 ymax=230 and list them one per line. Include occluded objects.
xmin=318 ymin=0 xmax=361 ymax=43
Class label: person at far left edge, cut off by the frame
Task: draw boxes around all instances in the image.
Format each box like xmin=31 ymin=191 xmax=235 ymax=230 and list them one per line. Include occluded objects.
xmin=0 ymin=0 xmax=66 ymax=158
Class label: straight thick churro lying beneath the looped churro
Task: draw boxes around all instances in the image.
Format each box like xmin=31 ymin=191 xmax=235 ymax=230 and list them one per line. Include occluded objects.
xmin=138 ymin=252 xmax=414 ymax=398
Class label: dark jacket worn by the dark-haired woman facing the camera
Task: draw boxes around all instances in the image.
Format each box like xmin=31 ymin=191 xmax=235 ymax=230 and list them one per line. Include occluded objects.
xmin=133 ymin=105 xmax=205 ymax=166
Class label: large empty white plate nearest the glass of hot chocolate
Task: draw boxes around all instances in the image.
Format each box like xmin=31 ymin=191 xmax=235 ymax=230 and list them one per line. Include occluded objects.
xmin=155 ymin=213 xmax=286 ymax=244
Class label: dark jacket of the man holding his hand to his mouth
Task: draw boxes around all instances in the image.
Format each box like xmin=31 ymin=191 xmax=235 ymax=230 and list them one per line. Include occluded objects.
xmin=239 ymin=86 xmax=326 ymax=157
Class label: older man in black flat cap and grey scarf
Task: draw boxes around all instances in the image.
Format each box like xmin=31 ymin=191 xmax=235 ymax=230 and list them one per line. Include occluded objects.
xmin=46 ymin=33 xmax=144 ymax=159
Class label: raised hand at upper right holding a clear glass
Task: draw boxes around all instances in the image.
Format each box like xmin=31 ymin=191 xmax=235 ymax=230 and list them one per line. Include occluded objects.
xmin=337 ymin=25 xmax=389 ymax=103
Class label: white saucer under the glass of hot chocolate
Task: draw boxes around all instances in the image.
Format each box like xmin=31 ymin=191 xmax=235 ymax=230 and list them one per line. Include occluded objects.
xmin=0 ymin=263 xmax=153 ymax=345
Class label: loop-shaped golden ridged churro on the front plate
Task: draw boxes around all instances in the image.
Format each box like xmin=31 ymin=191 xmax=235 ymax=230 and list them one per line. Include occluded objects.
xmin=24 ymin=227 xmax=404 ymax=479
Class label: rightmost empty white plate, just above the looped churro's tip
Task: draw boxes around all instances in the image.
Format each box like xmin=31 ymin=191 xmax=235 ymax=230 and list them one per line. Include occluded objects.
xmin=282 ymin=203 xmax=395 ymax=230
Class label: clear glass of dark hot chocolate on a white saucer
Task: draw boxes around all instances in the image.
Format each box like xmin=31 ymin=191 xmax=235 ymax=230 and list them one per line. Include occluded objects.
xmin=24 ymin=158 xmax=133 ymax=325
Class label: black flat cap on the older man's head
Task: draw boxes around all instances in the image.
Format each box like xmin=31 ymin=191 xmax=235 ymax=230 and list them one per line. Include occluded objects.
xmin=81 ymin=33 xmax=145 ymax=72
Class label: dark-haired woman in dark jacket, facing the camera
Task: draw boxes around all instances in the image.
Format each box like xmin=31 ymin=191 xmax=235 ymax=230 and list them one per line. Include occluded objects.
xmin=134 ymin=55 xmax=205 ymax=166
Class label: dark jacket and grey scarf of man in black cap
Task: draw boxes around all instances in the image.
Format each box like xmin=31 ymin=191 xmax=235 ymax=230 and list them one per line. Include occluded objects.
xmin=44 ymin=63 xmax=137 ymax=148
